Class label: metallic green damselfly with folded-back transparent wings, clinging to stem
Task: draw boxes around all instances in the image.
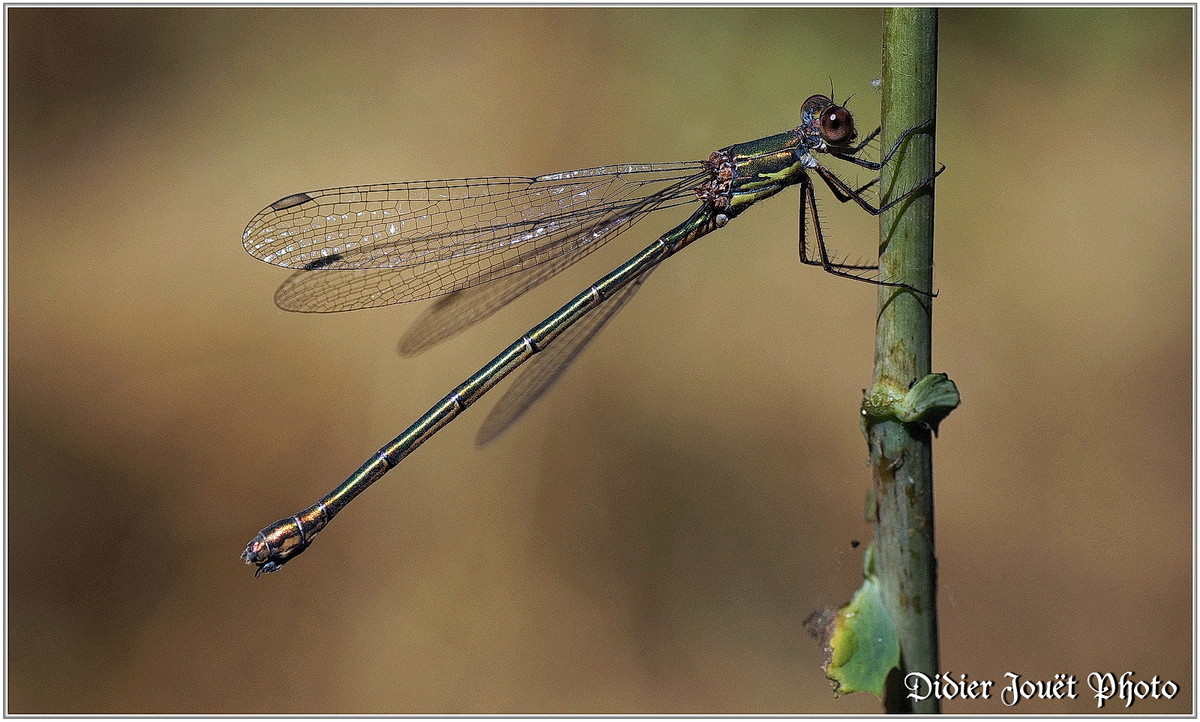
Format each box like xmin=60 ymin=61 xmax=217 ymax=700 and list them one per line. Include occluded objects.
xmin=242 ymin=95 xmax=941 ymax=576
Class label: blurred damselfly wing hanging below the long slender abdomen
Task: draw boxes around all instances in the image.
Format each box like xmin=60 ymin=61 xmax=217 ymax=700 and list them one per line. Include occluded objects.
xmin=475 ymin=265 xmax=658 ymax=446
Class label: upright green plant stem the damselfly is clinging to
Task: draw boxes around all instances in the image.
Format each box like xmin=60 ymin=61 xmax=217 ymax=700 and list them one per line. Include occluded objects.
xmin=868 ymin=7 xmax=941 ymax=714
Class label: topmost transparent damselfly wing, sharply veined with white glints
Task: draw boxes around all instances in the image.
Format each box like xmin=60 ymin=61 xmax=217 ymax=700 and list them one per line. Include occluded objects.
xmin=242 ymin=162 xmax=703 ymax=297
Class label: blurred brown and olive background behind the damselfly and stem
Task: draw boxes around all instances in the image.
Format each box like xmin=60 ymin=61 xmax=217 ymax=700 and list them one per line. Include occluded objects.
xmin=7 ymin=8 xmax=1194 ymax=714
